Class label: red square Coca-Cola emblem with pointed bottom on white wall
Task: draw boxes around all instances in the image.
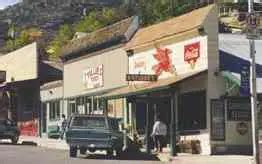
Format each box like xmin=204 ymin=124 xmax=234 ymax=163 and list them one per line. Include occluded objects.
xmin=184 ymin=42 xmax=200 ymax=69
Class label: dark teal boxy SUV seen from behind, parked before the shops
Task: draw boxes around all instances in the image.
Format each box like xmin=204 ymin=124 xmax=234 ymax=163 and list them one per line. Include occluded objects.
xmin=66 ymin=115 xmax=123 ymax=157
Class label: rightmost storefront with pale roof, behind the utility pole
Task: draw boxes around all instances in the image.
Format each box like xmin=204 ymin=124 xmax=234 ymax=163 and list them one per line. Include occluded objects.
xmin=214 ymin=34 xmax=262 ymax=154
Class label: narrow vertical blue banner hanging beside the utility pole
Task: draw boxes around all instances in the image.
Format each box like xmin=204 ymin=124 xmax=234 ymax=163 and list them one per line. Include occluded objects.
xmin=240 ymin=65 xmax=250 ymax=96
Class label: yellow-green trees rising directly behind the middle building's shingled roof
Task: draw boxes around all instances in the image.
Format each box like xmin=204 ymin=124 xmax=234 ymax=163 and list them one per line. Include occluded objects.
xmin=46 ymin=8 xmax=129 ymax=60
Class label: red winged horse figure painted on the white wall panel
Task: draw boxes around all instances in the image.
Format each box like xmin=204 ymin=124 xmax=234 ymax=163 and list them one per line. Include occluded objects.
xmin=152 ymin=48 xmax=176 ymax=76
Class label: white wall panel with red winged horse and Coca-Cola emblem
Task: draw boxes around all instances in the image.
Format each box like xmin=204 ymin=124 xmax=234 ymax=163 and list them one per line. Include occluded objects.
xmin=128 ymin=36 xmax=208 ymax=81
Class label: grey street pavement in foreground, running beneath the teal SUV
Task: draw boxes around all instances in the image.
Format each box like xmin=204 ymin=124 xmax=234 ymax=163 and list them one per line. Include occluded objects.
xmin=0 ymin=144 xmax=161 ymax=164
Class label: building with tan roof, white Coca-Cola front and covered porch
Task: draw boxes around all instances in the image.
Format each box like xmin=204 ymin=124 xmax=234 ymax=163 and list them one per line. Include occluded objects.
xmin=103 ymin=5 xmax=225 ymax=155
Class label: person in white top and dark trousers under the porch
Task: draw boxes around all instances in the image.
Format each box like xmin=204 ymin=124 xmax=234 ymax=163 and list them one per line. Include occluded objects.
xmin=151 ymin=115 xmax=167 ymax=152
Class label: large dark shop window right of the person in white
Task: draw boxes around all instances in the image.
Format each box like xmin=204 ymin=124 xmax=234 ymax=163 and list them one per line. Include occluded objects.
xmin=178 ymin=91 xmax=206 ymax=133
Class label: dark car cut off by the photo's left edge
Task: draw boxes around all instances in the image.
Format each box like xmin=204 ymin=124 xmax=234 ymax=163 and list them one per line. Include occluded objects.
xmin=0 ymin=119 xmax=20 ymax=144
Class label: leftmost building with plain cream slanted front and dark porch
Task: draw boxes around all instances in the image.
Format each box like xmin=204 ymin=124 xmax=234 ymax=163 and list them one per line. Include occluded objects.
xmin=0 ymin=43 xmax=61 ymax=136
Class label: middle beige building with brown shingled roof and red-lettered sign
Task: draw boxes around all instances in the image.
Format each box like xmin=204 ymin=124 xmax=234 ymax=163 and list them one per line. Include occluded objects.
xmin=62 ymin=17 xmax=138 ymax=117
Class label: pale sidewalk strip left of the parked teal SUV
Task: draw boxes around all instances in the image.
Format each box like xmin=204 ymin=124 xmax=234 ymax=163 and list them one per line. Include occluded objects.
xmin=18 ymin=136 xmax=69 ymax=150
